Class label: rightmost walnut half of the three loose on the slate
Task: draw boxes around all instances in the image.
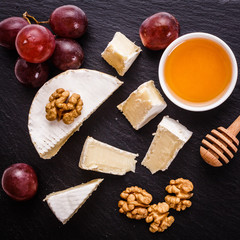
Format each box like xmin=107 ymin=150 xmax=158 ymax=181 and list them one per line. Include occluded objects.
xmin=165 ymin=178 xmax=193 ymax=211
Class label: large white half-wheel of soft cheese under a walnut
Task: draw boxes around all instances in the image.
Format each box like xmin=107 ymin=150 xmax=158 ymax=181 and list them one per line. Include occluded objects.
xmin=28 ymin=69 xmax=123 ymax=159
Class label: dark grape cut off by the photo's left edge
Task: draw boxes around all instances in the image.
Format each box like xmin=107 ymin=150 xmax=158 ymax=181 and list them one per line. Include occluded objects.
xmin=0 ymin=17 xmax=28 ymax=49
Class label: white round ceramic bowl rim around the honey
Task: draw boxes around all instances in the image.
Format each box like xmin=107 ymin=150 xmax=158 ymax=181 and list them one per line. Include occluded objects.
xmin=158 ymin=32 xmax=238 ymax=112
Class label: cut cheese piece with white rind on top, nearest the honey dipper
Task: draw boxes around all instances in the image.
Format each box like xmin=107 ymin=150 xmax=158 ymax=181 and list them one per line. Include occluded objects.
xmin=142 ymin=116 xmax=192 ymax=174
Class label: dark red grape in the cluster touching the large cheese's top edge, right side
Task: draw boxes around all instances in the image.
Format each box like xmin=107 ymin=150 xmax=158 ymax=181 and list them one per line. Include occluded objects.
xmin=52 ymin=38 xmax=84 ymax=71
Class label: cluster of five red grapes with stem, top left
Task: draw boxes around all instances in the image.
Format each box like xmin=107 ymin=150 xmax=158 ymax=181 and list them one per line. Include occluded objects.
xmin=0 ymin=5 xmax=88 ymax=87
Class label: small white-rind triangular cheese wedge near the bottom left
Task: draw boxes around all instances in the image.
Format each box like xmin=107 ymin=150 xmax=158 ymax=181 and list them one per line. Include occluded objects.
xmin=43 ymin=179 xmax=103 ymax=224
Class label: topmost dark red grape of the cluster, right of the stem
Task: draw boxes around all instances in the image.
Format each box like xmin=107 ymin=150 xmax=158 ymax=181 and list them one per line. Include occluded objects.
xmin=49 ymin=5 xmax=88 ymax=38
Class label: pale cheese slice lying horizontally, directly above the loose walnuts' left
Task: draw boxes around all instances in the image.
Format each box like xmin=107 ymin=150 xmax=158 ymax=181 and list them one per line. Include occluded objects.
xmin=79 ymin=137 xmax=138 ymax=175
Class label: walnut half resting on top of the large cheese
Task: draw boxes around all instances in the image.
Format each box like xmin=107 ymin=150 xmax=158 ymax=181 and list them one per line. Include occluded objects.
xmin=45 ymin=88 xmax=83 ymax=124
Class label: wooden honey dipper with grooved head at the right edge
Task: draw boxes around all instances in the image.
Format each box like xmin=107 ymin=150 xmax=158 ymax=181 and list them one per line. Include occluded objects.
xmin=200 ymin=115 xmax=240 ymax=167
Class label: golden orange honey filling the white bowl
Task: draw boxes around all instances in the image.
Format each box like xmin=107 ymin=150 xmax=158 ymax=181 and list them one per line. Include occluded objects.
xmin=163 ymin=38 xmax=232 ymax=106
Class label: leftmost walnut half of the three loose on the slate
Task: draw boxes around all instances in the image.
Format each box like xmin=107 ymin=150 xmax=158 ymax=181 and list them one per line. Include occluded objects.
xmin=118 ymin=186 xmax=152 ymax=220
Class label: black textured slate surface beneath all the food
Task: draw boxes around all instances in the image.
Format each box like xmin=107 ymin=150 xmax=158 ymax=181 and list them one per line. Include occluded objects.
xmin=0 ymin=0 xmax=240 ymax=240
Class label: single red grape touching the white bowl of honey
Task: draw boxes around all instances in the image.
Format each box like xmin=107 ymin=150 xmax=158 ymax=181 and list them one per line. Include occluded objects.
xmin=139 ymin=12 xmax=180 ymax=50
